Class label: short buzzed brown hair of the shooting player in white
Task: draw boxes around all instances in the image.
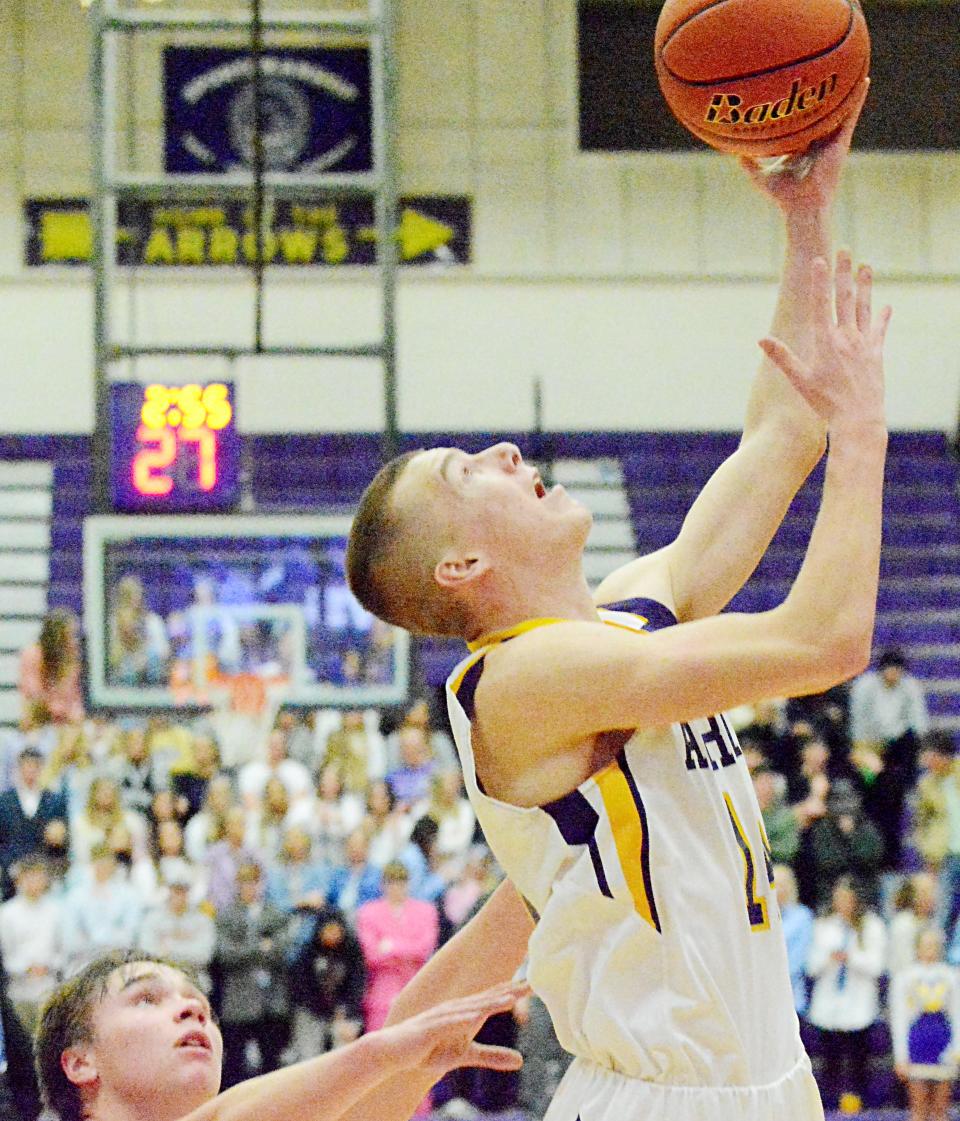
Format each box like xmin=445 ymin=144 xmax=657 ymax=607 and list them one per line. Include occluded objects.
xmin=347 ymin=452 xmax=465 ymax=637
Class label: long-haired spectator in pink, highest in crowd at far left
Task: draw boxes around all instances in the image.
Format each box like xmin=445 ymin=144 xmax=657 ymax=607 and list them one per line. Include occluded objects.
xmin=20 ymin=608 xmax=83 ymax=731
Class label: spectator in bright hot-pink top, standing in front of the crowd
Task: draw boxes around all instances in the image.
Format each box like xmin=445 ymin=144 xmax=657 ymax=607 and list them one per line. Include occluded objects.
xmin=357 ymin=861 xmax=440 ymax=1031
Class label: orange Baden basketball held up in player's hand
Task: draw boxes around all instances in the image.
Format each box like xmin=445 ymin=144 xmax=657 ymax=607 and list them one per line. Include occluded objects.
xmin=654 ymin=0 xmax=870 ymax=157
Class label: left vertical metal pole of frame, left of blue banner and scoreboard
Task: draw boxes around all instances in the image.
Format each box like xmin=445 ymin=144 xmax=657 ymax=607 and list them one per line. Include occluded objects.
xmin=90 ymin=0 xmax=116 ymax=512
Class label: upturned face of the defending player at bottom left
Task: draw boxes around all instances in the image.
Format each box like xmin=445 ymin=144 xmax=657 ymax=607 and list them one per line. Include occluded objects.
xmin=79 ymin=962 xmax=223 ymax=1121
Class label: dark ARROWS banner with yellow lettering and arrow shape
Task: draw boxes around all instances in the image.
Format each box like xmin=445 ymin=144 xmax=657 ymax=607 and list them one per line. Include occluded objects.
xmin=24 ymin=195 xmax=472 ymax=268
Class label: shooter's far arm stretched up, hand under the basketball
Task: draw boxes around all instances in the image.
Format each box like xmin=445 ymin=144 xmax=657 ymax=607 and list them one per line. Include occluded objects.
xmin=597 ymin=80 xmax=867 ymax=621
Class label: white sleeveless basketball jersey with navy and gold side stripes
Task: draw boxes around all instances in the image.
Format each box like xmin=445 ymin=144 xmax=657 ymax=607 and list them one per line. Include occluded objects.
xmin=446 ymin=600 xmax=803 ymax=1087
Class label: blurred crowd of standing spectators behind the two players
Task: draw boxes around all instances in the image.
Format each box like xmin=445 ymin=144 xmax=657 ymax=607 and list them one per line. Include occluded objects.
xmin=0 ymin=620 xmax=960 ymax=1119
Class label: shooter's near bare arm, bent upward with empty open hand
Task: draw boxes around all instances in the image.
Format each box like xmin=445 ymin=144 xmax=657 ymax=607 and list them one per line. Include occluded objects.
xmin=476 ymin=254 xmax=889 ymax=794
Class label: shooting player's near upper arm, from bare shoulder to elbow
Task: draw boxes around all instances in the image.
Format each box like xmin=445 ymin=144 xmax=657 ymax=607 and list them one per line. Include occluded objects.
xmin=476 ymin=604 xmax=859 ymax=784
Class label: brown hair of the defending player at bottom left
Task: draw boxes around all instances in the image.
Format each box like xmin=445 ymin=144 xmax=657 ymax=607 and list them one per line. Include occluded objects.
xmin=34 ymin=949 xmax=195 ymax=1121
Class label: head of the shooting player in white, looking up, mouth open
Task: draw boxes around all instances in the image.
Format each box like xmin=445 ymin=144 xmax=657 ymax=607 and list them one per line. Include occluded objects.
xmin=347 ymin=443 xmax=591 ymax=638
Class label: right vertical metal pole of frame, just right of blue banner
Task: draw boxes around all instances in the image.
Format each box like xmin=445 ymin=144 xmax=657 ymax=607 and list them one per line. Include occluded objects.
xmin=370 ymin=0 xmax=400 ymax=461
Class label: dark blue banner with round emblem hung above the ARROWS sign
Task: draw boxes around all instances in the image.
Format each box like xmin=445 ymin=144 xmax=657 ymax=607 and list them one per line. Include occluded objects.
xmin=164 ymin=46 xmax=372 ymax=174
